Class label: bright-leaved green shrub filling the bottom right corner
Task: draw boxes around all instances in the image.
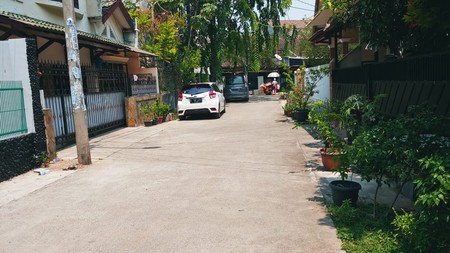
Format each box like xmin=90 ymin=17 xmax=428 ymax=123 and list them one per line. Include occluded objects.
xmin=392 ymin=153 xmax=450 ymax=252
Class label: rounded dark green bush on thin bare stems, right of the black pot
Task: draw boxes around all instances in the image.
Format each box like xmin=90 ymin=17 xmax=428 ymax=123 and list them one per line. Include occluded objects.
xmin=347 ymin=105 xmax=449 ymax=216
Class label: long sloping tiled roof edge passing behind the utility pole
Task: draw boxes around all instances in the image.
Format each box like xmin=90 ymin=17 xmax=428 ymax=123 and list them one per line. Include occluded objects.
xmin=0 ymin=11 xmax=126 ymax=47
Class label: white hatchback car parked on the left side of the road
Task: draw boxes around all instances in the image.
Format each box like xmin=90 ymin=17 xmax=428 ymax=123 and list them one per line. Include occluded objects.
xmin=178 ymin=82 xmax=225 ymax=120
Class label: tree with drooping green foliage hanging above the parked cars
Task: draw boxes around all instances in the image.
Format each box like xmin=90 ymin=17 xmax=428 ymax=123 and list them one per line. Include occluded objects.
xmin=124 ymin=0 xmax=298 ymax=86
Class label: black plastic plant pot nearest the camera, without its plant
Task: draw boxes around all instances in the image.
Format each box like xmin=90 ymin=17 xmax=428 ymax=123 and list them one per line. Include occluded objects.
xmin=330 ymin=180 xmax=361 ymax=207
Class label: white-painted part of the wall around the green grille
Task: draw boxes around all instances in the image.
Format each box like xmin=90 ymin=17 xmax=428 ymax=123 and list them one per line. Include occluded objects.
xmin=0 ymin=39 xmax=37 ymax=133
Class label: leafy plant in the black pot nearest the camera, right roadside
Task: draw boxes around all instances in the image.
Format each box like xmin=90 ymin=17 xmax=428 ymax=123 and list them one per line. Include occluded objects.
xmin=326 ymin=94 xmax=388 ymax=206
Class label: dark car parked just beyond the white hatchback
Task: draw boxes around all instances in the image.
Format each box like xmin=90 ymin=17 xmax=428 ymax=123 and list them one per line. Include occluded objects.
xmin=223 ymin=74 xmax=249 ymax=101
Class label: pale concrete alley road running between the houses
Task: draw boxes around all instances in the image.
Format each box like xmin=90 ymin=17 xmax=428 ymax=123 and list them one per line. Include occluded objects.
xmin=0 ymin=97 xmax=341 ymax=253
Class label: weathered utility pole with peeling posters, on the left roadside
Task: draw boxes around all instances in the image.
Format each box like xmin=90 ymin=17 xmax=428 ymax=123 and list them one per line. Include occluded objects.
xmin=62 ymin=0 xmax=92 ymax=165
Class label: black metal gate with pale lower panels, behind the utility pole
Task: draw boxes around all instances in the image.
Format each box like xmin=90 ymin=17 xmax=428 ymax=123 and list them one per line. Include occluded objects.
xmin=39 ymin=63 xmax=128 ymax=149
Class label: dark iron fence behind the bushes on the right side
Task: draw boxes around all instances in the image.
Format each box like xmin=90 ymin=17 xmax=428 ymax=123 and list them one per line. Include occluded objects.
xmin=332 ymin=52 xmax=450 ymax=117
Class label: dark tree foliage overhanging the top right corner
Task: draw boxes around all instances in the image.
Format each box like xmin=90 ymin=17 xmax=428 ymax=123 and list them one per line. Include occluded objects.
xmin=324 ymin=0 xmax=450 ymax=56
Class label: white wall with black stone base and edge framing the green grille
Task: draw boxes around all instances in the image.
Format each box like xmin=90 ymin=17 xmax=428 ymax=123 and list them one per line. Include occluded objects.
xmin=0 ymin=39 xmax=46 ymax=181
